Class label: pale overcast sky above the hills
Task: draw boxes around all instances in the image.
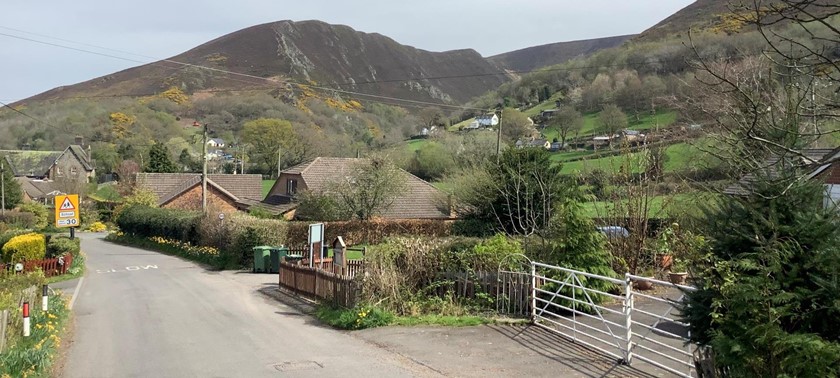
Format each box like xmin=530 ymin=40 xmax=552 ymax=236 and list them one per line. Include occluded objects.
xmin=0 ymin=0 xmax=693 ymax=103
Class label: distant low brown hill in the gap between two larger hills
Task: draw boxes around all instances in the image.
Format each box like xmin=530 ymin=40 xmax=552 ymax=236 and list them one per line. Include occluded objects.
xmin=487 ymin=35 xmax=634 ymax=71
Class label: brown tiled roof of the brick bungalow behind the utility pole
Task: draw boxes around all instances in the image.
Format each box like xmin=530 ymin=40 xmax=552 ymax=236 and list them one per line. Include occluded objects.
xmin=137 ymin=173 xmax=262 ymax=204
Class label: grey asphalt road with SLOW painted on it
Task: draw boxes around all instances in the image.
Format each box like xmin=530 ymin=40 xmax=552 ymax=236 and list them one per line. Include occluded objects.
xmin=63 ymin=235 xmax=437 ymax=378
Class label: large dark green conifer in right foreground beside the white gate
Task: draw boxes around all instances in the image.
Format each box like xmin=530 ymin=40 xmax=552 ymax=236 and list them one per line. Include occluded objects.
xmin=682 ymin=175 xmax=840 ymax=377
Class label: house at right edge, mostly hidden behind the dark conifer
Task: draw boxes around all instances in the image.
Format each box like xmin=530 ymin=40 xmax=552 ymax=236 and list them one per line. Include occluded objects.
xmin=723 ymin=148 xmax=840 ymax=207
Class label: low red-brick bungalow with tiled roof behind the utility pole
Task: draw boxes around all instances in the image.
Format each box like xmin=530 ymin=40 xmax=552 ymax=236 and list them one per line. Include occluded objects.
xmin=137 ymin=173 xmax=262 ymax=212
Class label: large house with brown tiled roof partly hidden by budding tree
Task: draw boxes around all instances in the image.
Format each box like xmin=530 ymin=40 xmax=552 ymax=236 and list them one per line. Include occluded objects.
xmin=260 ymin=157 xmax=454 ymax=219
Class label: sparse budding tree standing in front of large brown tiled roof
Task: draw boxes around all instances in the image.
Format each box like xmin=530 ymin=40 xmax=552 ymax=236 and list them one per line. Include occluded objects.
xmin=329 ymin=156 xmax=406 ymax=220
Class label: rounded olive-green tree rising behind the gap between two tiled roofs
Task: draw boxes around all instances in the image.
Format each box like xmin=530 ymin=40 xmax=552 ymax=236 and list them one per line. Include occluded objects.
xmin=242 ymin=118 xmax=297 ymax=175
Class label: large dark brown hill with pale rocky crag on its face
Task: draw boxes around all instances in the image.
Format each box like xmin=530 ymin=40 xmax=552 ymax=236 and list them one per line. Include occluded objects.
xmin=24 ymin=21 xmax=508 ymax=103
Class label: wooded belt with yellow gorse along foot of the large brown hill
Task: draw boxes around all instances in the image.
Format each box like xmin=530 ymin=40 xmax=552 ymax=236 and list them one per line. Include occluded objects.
xmin=0 ymin=89 xmax=419 ymax=174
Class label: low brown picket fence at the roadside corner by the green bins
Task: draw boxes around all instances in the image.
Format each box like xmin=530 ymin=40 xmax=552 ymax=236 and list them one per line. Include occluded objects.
xmin=280 ymin=259 xmax=359 ymax=308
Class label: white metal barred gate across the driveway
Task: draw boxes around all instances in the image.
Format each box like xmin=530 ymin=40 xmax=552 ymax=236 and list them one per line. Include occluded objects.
xmin=530 ymin=262 xmax=697 ymax=377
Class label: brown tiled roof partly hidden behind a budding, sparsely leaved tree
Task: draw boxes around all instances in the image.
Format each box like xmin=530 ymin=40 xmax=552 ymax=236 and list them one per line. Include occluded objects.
xmin=283 ymin=157 xmax=451 ymax=219
